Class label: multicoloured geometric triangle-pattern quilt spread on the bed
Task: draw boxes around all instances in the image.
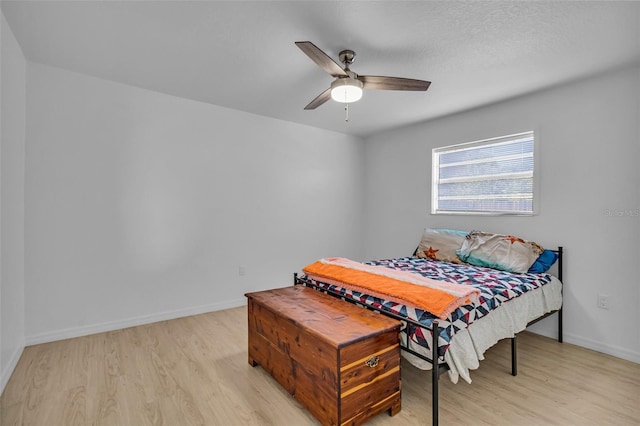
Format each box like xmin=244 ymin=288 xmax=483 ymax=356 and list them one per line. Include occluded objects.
xmin=302 ymin=257 xmax=551 ymax=358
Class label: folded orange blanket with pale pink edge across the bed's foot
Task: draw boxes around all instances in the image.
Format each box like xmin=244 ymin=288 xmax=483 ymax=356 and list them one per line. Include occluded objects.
xmin=302 ymin=258 xmax=480 ymax=319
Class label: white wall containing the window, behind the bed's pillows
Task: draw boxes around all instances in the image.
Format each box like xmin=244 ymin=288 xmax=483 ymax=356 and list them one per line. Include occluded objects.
xmin=365 ymin=67 xmax=640 ymax=362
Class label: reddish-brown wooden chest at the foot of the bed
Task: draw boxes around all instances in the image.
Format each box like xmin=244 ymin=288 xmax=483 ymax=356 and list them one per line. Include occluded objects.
xmin=246 ymin=286 xmax=401 ymax=425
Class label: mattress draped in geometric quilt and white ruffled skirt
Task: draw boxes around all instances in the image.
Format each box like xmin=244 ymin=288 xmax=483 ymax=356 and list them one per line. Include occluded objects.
xmin=302 ymin=257 xmax=562 ymax=383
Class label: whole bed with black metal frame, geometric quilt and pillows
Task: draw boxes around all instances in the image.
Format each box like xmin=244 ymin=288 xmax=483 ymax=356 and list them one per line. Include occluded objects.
xmin=294 ymin=229 xmax=563 ymax=425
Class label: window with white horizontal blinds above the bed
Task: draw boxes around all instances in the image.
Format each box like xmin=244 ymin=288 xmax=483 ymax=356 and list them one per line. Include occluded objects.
xmin=431 ymin=132 xmax=534 ymax=215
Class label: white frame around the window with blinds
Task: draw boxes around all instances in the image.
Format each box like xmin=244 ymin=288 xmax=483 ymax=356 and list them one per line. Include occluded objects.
xmin=431 ymin=130 xmax=540 ymax=216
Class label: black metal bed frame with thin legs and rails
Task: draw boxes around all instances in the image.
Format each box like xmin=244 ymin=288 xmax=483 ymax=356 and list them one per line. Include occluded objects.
xmin=293 ymin=246 xmax=564 ymax=426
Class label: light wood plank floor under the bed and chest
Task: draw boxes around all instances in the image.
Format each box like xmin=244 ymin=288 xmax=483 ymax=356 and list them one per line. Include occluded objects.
xmin=0 ymin=307 xmax=640 ymax=426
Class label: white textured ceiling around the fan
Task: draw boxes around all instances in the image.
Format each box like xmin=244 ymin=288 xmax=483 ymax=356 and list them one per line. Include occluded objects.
xmin=1 ymin=0 xmax=640 ymax=136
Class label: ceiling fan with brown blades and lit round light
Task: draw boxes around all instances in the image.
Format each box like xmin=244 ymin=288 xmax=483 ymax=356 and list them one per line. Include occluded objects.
xmin=296 ymin=41 xmax=431 ymax=109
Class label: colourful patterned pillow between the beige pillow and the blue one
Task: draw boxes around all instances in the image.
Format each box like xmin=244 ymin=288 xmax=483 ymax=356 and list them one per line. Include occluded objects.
xmin=456 ymin=231 xmax=544 ymax=273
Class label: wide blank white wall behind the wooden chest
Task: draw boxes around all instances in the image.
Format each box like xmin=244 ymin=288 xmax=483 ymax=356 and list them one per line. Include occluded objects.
xmin=25 ymin=63 xmax=364 ymax=344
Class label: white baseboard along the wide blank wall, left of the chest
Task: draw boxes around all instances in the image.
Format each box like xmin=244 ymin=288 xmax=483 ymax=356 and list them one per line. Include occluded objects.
xmin=25 ymin=298 xmax=247 ymax=346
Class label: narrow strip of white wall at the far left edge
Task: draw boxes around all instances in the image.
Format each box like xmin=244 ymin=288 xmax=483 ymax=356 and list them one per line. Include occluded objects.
xmin=0 ymin=15 xmax=26 ymax=393
